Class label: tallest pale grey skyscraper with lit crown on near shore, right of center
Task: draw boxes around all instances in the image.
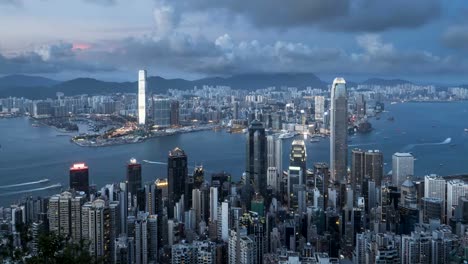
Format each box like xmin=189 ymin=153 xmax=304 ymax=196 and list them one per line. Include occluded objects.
xmin=330 ymin=78 xmax=348 ymax=183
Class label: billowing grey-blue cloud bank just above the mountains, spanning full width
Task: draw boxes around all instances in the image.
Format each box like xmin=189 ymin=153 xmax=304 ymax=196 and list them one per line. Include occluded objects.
xmin=0 ymin=32 xmax=468 ymax=76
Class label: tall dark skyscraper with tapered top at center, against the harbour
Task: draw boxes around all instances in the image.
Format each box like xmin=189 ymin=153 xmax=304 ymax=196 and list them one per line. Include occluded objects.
xmin=246 ymin=120 xmax=267 ymax=197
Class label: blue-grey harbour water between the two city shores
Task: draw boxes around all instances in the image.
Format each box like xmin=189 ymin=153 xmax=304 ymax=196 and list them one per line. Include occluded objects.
xmin=0 ymin=102 xmax=468 ymax=205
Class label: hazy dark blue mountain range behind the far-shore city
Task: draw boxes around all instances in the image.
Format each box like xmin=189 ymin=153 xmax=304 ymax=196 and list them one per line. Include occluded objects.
xmin=0 ymin=73 xmax=416 ymax=99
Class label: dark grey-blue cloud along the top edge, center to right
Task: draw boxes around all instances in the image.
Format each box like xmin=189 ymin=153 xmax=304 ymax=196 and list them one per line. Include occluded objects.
xmin=171 ymin=0 xmax=442 ymax=32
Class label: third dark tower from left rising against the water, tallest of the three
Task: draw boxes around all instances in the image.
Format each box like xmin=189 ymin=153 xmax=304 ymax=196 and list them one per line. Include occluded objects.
xmin=167 ymin=148 xmax=188 ymax=218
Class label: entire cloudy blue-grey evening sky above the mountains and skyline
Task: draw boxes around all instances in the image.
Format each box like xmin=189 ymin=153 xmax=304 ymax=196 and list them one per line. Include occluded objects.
xmin=0 ymin=0 xmax=468 ymax=84
